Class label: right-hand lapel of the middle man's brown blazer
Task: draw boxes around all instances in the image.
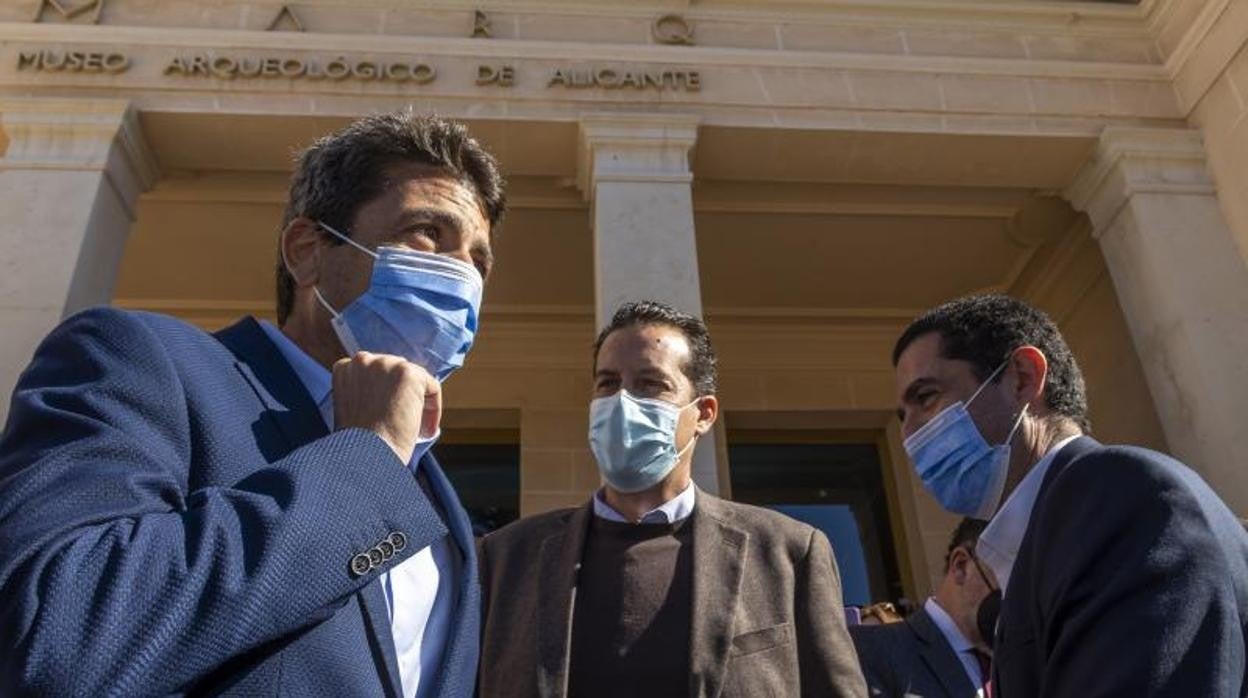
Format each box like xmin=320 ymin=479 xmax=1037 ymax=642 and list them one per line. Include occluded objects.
xmin=689 ymin=489 xmax=749 ymax=697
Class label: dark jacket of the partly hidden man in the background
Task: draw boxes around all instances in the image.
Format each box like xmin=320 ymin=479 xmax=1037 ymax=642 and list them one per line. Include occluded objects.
xmin=850 ymin=608 xmax=980 ymax=698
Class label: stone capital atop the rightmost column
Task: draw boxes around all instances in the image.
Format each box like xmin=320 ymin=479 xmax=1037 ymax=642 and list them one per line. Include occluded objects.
xmin=1066 ymin=126 xmax=1214 ymax=237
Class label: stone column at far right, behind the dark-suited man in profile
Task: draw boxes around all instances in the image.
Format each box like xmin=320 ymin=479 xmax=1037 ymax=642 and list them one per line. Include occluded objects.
xmin=1067 ymin=127 xmax=1248 ymax=517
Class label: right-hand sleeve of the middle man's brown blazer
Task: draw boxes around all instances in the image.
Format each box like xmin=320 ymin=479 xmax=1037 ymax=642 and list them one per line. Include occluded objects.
xmin=795 ymin=531 xmax=867 ymax=697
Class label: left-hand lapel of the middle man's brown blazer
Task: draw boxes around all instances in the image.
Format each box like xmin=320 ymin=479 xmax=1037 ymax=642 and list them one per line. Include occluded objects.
xmin=538 ymin=502 xmax=592 ymax=698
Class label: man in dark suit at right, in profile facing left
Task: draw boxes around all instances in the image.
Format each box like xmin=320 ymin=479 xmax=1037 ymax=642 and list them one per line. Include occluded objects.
xmin=894 ymin=295 xmax=1248 ymax=698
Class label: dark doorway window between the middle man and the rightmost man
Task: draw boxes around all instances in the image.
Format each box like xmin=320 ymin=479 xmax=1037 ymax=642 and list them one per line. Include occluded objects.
xmin=728 ymin=430 xmax=904 ymax=606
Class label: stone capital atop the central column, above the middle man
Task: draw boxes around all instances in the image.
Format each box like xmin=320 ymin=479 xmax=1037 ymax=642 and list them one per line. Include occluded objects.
xmin=577 ymin=114 xmax=699 ymax=200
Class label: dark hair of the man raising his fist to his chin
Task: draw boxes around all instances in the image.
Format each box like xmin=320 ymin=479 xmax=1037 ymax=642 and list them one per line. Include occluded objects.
xmin=277 ymin=109 xmax=507 ymax=325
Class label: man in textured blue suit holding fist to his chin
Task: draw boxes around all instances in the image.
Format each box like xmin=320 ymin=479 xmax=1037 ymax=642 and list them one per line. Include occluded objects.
xmin=0 ymin=112 xmax=504 ymax=698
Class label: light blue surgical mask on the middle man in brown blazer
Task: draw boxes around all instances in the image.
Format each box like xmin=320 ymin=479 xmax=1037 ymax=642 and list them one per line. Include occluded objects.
xmin=589 ymin=390 xmax=698 ymax=493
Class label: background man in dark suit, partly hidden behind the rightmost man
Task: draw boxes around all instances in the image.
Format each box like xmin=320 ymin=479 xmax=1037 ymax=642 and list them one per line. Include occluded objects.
xmin=850 ymin=518 xmax=993 ymax=698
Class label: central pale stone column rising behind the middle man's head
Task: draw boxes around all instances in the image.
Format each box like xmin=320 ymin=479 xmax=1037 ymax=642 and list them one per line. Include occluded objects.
xmin=578 ymin=114 xmax=721 ymax=493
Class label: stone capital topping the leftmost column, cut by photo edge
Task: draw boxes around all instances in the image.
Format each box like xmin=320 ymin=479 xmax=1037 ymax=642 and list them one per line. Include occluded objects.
xmin=0 ymin=97 xmax=160 ymax=219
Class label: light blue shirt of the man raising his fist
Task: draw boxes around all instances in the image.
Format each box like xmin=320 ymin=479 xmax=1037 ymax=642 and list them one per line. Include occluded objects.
xmin=260 ymin=322 xmax=461 ymax=698
